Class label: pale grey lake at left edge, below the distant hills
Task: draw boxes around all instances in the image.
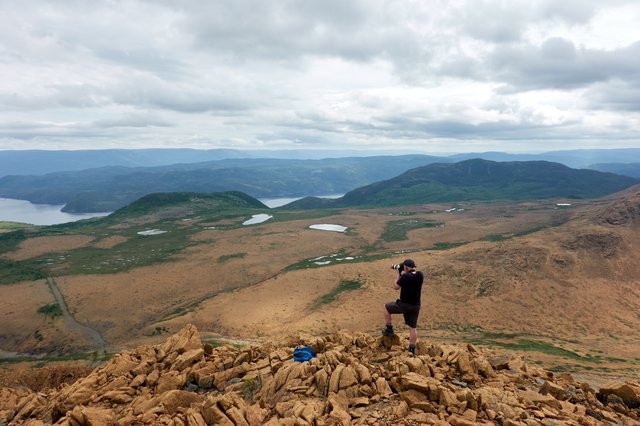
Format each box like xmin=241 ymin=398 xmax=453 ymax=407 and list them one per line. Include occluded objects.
xmin=0 ymin=198 xmax=109 ymax=225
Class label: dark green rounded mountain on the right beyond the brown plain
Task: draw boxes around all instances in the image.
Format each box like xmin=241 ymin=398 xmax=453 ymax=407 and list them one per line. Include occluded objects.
xmin=286 ymin=159 xmax=638 ymax=209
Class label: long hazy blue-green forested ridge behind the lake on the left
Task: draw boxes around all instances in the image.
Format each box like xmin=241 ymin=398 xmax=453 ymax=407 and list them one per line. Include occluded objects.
xmin=0 ymin=155 xmax=441 ymax=213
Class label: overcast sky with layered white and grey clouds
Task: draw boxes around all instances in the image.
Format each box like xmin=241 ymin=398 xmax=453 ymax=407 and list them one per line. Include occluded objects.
xmin=0 ymin=0 xmax=640 ymax=153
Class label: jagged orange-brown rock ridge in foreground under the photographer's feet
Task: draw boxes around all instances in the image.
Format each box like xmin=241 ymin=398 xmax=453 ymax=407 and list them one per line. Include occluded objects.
xmin=0 ymin=326 xmax=640 ymax=426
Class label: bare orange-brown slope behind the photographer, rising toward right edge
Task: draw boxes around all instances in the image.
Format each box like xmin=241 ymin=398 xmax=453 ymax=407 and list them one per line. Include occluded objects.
xmin=171 ymin=191 xmax=640 ymax=338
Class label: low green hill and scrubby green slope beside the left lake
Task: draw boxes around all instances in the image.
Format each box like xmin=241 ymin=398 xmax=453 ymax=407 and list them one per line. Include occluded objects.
xmin=0 ymin=192 xmax=268 ymax=285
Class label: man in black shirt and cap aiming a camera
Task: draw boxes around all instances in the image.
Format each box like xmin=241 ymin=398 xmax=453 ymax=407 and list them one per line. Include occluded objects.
xmin=382 ymin=259 xmax=424 ymax=354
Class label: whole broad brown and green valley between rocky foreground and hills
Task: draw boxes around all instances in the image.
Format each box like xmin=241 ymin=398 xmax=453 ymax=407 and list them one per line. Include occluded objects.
xmin=0 ymin=188 xmax=640 ymax=383
